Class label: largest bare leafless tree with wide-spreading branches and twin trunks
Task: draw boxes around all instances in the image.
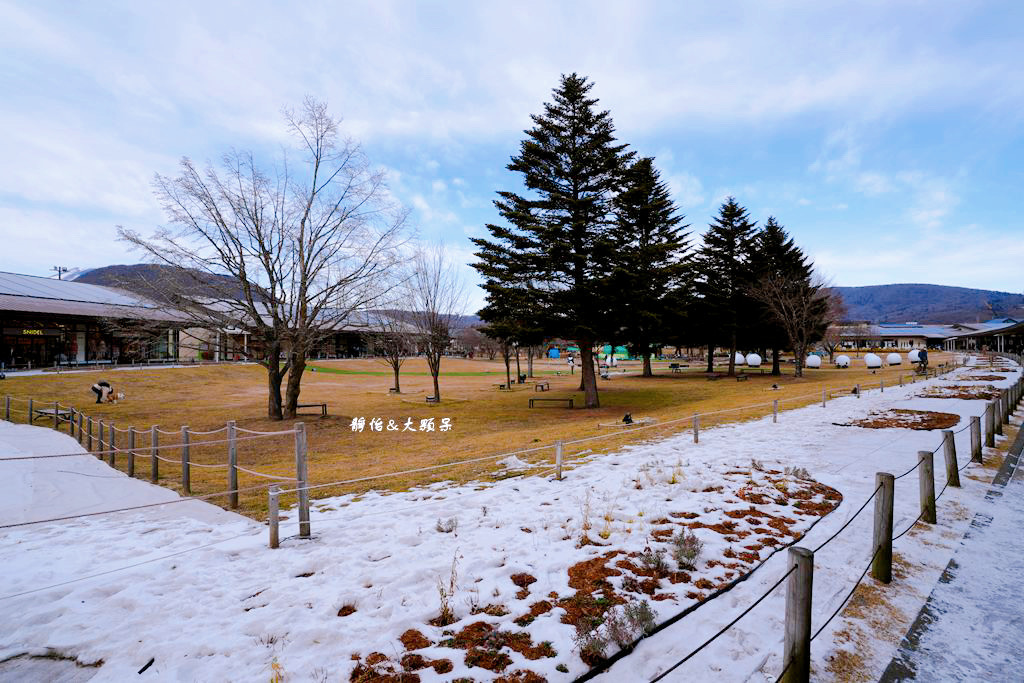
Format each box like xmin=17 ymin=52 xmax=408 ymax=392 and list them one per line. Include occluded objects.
xmin=119 ymin=98 xmax=407 ymax=419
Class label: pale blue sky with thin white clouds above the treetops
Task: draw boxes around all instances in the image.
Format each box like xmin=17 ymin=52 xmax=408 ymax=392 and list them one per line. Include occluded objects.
xmin=0 ymin=0 xmax=1024 ymax=309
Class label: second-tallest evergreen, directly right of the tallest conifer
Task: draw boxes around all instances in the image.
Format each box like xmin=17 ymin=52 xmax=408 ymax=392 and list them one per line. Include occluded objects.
xmin=610 ymin=157 xmax=689 ymax=377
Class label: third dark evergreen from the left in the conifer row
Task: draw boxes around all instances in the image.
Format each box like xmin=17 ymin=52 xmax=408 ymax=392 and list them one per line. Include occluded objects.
xmin=697 ymin=197 xmax=757 ymax=376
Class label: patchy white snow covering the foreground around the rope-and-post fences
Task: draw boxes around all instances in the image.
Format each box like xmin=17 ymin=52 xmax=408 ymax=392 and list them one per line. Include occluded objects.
xmin=0 ymin=360 xmax=1017 ymax=681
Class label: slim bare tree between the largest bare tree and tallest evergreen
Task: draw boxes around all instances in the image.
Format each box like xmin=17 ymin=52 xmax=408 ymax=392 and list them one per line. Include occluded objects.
xmin=409 ymin=246 xmax=467 ymax=400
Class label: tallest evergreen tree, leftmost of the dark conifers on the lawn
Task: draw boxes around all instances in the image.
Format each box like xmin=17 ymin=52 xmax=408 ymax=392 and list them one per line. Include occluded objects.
xmin=473 ymin=74 xmax=633 ymax=408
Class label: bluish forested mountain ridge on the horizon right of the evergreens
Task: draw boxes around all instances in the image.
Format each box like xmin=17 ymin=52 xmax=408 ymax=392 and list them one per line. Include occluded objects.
xmin=835 ymin=285 xmax=1024 ymax=323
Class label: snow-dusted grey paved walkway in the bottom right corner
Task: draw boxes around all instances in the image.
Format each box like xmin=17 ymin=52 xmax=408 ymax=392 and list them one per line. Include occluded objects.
xmin=882 ymin=419 xmax=1024 ymax=683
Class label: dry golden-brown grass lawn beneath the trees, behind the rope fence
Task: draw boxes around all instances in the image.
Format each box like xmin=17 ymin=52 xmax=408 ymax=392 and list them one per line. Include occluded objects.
xmin=0 ymin=354 xmax=946 ymax=516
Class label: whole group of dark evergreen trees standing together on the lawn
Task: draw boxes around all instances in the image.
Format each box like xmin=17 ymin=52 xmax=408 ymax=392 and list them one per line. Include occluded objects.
xmin=473 ymin=74 xmax=837 ymax=408
